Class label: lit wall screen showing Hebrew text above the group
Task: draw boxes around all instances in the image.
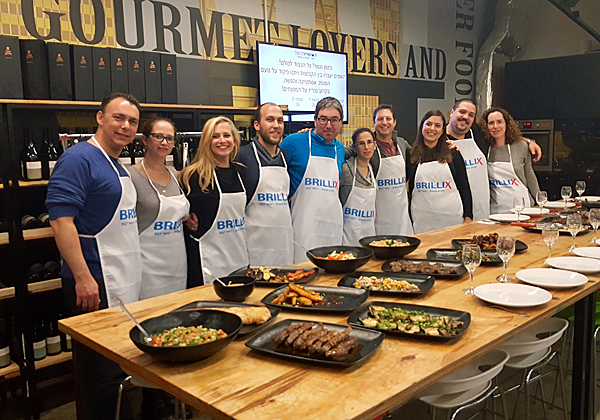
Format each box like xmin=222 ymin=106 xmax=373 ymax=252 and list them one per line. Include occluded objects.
xmin=258 ymin=43 xmax=348 ymax=122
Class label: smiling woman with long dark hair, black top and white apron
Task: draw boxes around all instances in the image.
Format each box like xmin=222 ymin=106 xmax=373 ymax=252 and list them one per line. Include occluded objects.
xmin=407 ymin=110 xmax=473 ymax=233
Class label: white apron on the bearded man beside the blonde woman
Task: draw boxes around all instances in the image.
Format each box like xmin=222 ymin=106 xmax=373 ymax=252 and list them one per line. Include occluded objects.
xmin=245 ymin=143 xmax=294 ymax=266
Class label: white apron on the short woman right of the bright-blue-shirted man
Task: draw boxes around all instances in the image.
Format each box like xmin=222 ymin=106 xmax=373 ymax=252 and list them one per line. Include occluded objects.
xmin=342 ymin=160 xmax=377 ymax=246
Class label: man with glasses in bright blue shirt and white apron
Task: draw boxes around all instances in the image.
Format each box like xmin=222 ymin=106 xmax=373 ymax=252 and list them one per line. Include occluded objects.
xmin=281 ymin=97 xmax=344 ymax=262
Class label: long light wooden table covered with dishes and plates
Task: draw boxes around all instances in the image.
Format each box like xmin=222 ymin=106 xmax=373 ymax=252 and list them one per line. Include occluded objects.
xmin=60 ymin=223 xmax=600 ymax=420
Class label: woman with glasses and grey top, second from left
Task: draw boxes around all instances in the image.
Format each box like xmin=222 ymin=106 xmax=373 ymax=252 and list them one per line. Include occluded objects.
xmin=131 ymin=117 xmax=190 ymax=299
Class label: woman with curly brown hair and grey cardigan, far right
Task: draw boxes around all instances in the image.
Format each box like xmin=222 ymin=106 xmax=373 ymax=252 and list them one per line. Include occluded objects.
xmin=479 ymin=108 xmax=540 ymax=213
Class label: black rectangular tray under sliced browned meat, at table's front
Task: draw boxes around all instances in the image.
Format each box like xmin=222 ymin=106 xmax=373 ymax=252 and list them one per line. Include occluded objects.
xmin=246 ymin=319 xmax=384 ymax=368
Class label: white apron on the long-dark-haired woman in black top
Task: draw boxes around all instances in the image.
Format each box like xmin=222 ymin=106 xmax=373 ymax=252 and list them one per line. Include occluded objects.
xmin=410 ymin=161 xmax=464 ymax=234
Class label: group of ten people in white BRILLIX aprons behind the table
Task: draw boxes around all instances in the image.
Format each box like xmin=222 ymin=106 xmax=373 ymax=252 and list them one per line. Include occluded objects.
xmin=46 ymin=93 xmax=541 ymax=418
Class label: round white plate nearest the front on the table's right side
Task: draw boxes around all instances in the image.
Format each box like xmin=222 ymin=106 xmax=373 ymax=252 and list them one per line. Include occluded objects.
xmin=475 ymin=283 xmax=552 ymax=308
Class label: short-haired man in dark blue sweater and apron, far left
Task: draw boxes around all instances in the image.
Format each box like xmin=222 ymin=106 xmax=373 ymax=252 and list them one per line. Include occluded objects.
xmin=46 ymin=93 xmax=142 ymax=419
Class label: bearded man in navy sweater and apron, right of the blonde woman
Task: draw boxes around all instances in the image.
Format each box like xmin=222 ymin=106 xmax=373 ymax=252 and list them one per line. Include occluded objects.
xmin=236 ymin=102 xmax=294 ymax=266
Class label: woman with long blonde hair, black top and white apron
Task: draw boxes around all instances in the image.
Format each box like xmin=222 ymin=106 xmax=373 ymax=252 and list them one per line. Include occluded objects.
xmin=179 ymin=116 xmax=248 ymax=287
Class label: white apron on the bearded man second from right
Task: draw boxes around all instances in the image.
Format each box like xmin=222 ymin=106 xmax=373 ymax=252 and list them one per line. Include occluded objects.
xmin=454 ymin=130 xmax=490 ymax=220
